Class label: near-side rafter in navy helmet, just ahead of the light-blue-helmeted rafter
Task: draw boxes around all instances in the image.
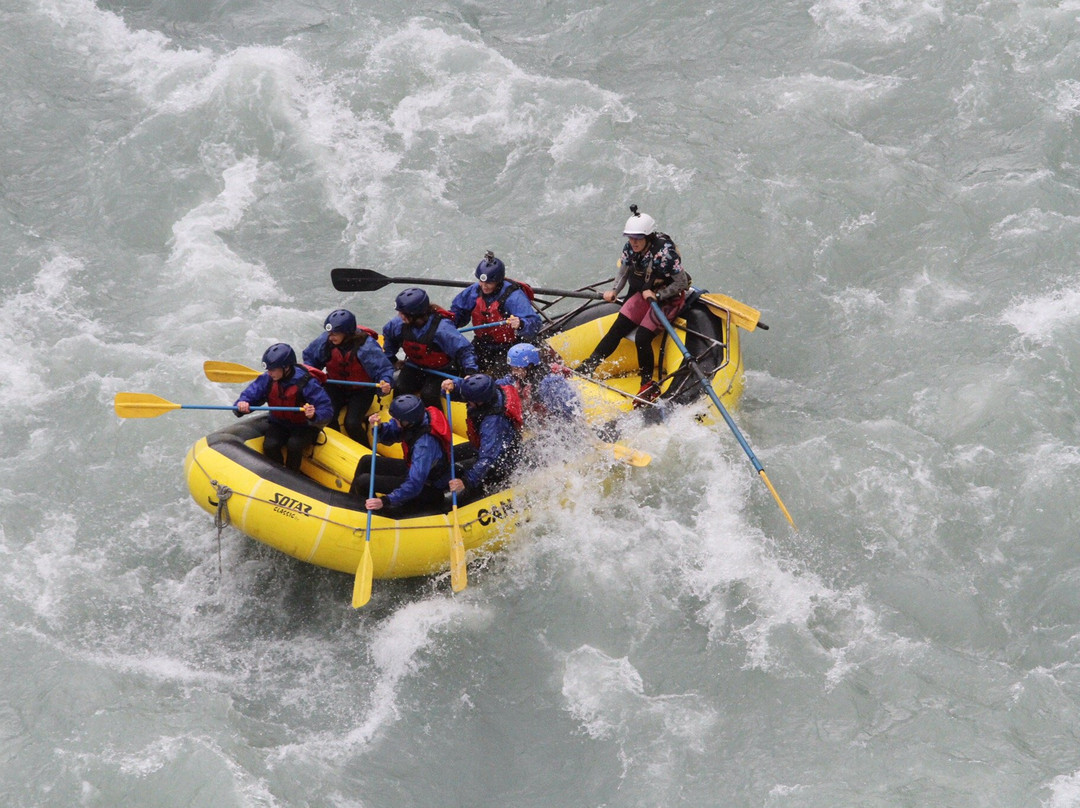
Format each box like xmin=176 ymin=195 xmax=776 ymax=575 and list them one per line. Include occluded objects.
xmin=443 ymin=373 xmax=522 ymax=497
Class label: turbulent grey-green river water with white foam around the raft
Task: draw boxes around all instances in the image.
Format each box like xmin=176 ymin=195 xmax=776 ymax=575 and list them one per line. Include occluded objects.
xmin=6 ymin=0 xmax=1080 ymax=808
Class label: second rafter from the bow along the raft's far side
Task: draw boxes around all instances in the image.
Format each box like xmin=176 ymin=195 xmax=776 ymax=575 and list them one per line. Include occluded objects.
xmin=303 ymin=309 xmax=394 ymax=446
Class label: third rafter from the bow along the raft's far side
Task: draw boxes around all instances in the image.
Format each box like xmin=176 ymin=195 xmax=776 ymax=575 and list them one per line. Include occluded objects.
xmin=382 ymin=288 xmax=480 ymax=406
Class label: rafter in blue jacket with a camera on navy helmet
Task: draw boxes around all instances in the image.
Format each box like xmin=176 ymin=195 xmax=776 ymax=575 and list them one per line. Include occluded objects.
xmin=450 ymin=250 xmax=541 ymax=375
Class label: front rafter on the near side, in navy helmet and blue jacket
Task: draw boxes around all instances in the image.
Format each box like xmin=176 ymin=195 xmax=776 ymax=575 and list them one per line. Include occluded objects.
xmin=352 ymin=394 xmax=454 ymax=511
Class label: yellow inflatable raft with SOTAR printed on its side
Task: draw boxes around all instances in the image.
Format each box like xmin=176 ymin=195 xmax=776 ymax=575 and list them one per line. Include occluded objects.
xmin=184 ymin=289 xmax=743 ymax=579
